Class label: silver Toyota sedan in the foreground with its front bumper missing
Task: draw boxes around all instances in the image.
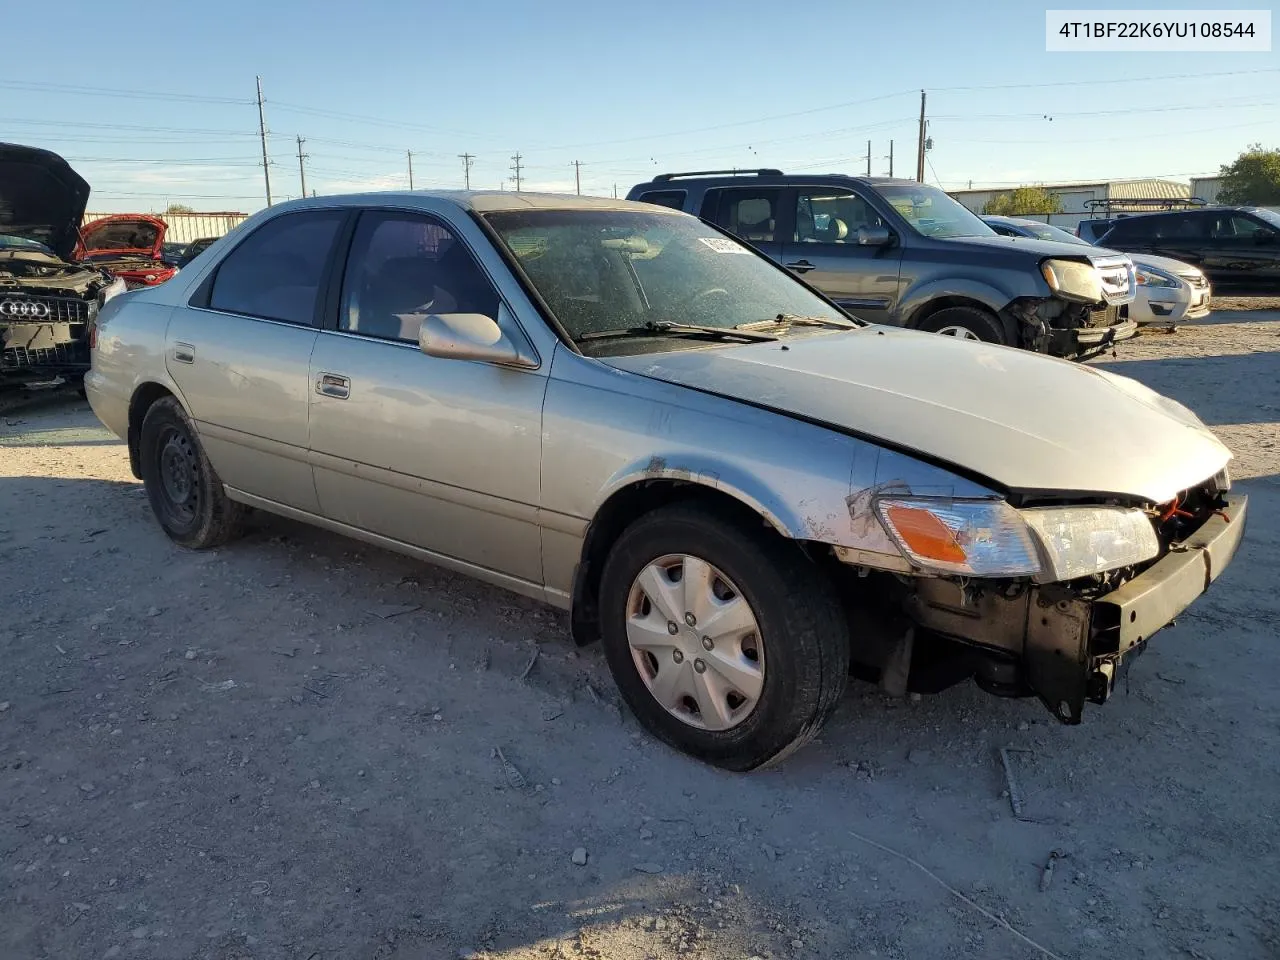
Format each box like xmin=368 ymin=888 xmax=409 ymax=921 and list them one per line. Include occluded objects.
xmin=86 ymin=192 xmax=1245 ymax=771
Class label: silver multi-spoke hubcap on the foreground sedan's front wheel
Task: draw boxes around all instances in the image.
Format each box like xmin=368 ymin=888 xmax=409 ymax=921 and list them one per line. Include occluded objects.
xmin=627 ymin=554 xmax=764 ymax=730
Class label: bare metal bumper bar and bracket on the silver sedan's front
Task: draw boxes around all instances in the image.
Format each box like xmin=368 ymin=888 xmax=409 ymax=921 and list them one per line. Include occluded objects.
xmin=910 ymin=495 xmax=1248 ymax=723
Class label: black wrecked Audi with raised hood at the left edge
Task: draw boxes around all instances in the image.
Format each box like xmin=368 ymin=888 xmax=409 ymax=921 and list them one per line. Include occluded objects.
xmin=0 ymin=143 xmax=124 ymax=385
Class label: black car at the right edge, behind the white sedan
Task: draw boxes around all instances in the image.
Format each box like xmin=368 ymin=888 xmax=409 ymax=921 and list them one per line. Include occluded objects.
xmin=1100 ymin=206 xmax=1280 ymax=296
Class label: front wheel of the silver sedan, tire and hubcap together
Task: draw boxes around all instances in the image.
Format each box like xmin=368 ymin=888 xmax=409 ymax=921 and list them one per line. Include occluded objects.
xmin=600 ymin=504 xmax=849 ymax=771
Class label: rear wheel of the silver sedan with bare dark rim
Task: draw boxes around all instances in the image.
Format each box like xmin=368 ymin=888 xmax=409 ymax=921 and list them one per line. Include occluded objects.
xmin=138 ymin=397 xmax=248 ymax=550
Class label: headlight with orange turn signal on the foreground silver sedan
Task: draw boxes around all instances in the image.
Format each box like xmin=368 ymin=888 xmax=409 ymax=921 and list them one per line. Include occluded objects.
xmin=877 ymin=498 xmax=1160 ymax=582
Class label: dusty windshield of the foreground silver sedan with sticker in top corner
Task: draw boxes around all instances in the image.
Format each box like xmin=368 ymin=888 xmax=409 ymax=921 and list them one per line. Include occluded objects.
xmin=485 ymin=210 xmax=849 ymax=340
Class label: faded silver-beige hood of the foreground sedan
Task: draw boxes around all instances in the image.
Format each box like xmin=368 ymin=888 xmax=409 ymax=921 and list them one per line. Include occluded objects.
xmin=600 ymin=326 xmax=1231 ymax=503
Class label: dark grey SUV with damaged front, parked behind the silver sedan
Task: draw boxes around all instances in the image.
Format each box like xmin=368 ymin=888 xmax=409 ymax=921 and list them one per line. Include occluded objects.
xmin=627 ymin=170 xmax=1137 ymax=358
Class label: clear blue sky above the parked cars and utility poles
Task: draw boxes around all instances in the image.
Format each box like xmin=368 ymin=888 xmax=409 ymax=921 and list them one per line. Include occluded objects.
xmin=0 ymin=0 xmax=1280 ymax=211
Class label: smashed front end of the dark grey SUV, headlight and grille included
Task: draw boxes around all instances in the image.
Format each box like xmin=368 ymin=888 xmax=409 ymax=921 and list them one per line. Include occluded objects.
xmin=1004 ymin=253 xmax=1138 ymax=360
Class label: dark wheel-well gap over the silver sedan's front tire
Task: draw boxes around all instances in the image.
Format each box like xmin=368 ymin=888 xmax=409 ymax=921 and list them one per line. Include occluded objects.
xmin=570 ymin=480 xmax=799 ymax=646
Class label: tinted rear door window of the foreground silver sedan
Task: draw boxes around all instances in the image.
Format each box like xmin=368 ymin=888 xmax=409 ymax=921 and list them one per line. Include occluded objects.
xmin=209 ymin=210 xmax=346 ymax=326
